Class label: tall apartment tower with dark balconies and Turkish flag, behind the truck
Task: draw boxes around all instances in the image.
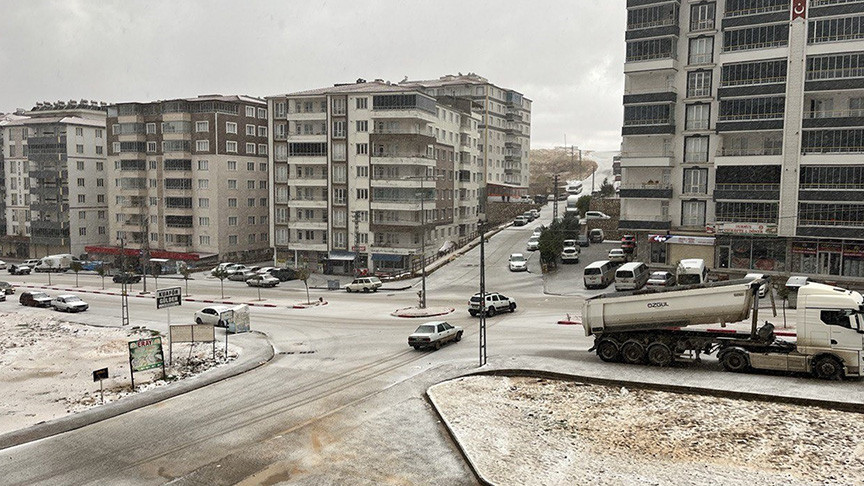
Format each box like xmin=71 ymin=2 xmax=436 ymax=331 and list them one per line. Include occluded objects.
xmin=620 ymin=0 xmax=864 ymax=279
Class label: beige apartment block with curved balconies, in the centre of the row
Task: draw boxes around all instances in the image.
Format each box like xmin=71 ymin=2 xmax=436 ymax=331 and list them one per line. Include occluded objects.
xmin=267 ymin=79 xmax=483 ymax=273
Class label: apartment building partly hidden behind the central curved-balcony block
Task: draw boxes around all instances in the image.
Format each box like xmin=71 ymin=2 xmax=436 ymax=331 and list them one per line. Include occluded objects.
xmin=399 ymin=73 xmax=531 ymax=201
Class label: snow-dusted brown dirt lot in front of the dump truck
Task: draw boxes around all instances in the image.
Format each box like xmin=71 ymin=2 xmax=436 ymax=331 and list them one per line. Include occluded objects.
xmin=429 ymin=376 xmax=864 ymax=486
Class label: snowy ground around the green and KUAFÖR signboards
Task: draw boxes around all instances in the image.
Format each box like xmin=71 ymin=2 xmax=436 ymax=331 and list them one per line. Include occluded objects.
xmin=0 ymin=312 xmax=239 ymax=434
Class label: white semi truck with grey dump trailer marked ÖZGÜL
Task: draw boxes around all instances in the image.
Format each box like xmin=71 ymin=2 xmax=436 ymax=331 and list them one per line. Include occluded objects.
xmin=582 ymin=279 xmax=864 ymax=379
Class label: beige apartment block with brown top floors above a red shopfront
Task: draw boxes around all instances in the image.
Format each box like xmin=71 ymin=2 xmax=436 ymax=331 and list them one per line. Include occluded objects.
xmin=88 ymin=95 xmax=272 ymax=268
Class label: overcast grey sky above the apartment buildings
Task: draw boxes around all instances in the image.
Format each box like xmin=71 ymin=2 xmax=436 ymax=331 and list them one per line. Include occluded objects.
xmin=0 ymin=0 xmax=626 ymax=150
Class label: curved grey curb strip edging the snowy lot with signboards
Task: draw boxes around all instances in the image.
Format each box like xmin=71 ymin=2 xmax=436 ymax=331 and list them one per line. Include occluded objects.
xmin=0 ymin=331 xmax=274 ymax=450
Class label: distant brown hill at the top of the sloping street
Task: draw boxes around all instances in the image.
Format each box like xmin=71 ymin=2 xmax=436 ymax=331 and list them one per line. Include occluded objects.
xmin=528 ymin=147 xmax=597 ymax=194
